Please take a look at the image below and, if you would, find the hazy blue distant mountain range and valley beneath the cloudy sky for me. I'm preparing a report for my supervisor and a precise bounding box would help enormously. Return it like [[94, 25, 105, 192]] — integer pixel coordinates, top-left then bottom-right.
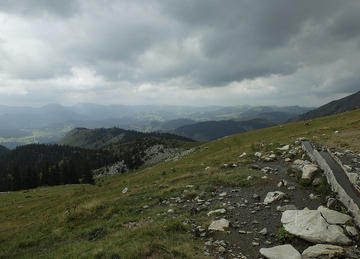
[[0, 104, 311, 148]]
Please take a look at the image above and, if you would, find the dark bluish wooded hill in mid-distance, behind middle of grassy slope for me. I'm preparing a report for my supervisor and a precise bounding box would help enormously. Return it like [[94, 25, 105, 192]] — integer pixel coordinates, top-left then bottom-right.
[[174, 119, 276, 141]]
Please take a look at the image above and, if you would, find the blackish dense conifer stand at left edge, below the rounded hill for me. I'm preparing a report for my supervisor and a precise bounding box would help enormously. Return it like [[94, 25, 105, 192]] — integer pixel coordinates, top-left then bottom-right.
[[0, 144, 116, 191]]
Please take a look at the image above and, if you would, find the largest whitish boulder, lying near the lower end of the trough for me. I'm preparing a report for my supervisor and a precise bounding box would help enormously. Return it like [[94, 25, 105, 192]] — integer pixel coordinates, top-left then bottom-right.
[[281, 210, 351, 245]]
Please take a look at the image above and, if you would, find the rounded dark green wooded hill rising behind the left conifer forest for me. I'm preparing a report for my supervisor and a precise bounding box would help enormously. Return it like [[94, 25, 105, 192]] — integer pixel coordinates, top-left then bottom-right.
[[58, 128, 192, 149]]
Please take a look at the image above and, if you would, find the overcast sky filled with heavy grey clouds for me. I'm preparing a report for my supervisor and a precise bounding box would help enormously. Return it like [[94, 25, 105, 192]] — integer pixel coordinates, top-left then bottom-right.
[[0, 0, 360, 106]]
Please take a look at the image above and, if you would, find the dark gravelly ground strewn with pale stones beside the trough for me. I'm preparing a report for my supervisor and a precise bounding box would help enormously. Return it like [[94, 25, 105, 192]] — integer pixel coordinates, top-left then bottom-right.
[[153, 142, 360, 258]]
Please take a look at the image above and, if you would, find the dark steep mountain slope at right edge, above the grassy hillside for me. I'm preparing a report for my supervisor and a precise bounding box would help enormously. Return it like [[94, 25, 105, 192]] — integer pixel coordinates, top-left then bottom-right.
[[291, 91, 360, 121]]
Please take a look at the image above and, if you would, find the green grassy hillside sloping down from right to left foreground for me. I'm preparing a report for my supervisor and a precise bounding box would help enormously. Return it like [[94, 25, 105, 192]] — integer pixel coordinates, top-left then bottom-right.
[[0, 110, 360, 258]]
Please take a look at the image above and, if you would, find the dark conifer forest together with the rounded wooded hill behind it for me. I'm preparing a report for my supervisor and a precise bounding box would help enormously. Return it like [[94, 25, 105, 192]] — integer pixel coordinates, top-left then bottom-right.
[[0, 128, 197, 191]]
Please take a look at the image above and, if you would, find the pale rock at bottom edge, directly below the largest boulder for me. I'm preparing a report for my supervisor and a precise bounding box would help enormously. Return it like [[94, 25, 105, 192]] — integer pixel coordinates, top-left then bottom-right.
[[302, 244, 345, 259]]
